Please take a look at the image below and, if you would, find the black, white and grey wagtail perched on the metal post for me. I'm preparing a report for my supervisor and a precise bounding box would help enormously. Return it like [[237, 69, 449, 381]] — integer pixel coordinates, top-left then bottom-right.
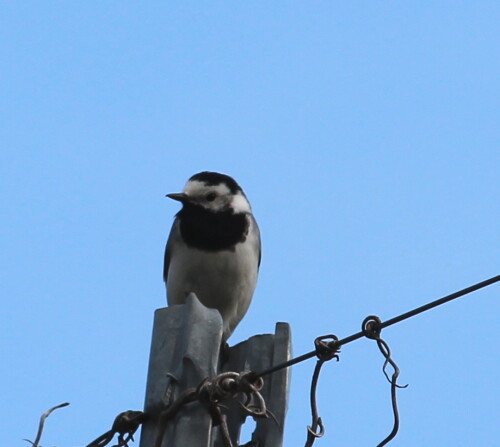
[[163, 172, 261, 341]]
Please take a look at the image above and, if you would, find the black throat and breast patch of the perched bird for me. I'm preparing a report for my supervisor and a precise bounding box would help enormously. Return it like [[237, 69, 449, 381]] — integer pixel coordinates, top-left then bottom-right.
[[177, 203, 249, 251]]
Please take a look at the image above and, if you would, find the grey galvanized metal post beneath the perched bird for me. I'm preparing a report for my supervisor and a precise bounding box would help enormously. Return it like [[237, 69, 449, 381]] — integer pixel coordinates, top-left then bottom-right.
[[140, 294, 291, 447]]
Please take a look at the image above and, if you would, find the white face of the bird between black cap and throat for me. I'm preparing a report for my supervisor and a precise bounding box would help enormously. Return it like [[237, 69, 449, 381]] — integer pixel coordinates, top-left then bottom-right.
[[183, 180, 251, 213]]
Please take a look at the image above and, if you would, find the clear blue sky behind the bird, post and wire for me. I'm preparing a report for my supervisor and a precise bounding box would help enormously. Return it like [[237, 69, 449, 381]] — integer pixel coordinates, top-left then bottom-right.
[[0, 0, 500, 447]]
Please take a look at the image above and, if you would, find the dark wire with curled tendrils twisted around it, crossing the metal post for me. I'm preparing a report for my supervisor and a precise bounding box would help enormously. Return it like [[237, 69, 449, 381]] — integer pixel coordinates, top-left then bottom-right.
[[80, 275, 500, 447]]
